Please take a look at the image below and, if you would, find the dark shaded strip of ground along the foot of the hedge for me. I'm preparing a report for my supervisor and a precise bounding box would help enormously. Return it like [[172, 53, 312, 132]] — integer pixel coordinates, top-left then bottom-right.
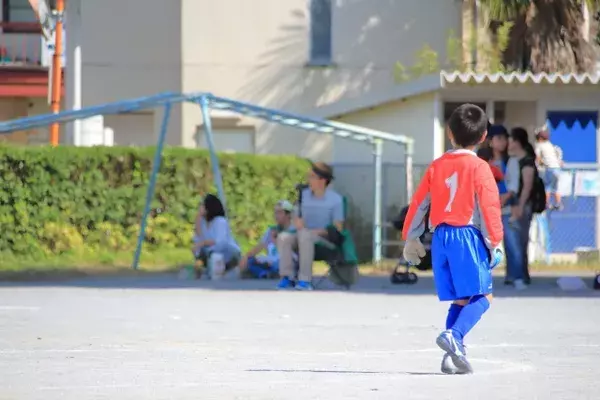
[[0, 272, 600, 298]]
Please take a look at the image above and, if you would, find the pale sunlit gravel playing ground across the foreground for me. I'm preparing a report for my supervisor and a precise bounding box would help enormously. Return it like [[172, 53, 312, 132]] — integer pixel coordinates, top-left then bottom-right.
[[0, 275, 600, 400]]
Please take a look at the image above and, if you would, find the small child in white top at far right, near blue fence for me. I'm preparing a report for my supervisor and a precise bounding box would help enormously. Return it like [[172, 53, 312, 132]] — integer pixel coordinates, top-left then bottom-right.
[[535, 126, 563, 210]]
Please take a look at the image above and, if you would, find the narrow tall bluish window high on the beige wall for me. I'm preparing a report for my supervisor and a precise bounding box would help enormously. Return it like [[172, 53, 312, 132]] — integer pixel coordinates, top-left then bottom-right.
[[309, 0, 332, 65]]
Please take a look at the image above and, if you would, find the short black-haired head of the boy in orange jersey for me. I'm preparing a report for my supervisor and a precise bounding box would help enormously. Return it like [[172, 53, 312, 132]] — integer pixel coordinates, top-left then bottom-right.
[[448, 103, 489, 147]]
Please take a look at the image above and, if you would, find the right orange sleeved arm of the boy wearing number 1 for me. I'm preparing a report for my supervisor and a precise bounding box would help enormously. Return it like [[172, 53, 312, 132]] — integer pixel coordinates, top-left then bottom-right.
[[475, 165, 504, 249]]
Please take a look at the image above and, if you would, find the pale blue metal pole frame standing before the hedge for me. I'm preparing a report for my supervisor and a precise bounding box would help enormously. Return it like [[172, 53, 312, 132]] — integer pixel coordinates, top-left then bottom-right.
[[0, 93, 414, 269]]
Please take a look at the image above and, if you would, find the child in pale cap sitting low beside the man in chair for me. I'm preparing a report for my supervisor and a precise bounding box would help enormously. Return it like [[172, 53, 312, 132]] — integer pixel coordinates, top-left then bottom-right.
[[240, 200, 294, 279]]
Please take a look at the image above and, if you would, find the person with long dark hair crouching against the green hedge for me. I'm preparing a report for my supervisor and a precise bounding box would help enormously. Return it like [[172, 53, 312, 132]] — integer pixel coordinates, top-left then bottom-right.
[[193, 194, 240, 276]]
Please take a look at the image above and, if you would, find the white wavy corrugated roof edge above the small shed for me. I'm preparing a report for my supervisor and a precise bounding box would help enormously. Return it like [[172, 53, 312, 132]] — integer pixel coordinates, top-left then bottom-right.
[[440, 71, 600, 85]]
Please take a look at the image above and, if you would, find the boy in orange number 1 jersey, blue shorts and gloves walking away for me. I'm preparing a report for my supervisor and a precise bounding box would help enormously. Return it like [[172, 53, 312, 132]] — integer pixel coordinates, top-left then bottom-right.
[[402, 104, 503, 374]]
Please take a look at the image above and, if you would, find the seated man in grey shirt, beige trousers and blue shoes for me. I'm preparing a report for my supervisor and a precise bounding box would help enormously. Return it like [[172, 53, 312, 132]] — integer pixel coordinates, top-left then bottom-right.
[[277, 162, 344, 290]]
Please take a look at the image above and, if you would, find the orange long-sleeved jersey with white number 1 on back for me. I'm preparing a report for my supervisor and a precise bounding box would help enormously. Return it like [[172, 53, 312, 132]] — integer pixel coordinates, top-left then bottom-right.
[[402, 150, 503, 248]]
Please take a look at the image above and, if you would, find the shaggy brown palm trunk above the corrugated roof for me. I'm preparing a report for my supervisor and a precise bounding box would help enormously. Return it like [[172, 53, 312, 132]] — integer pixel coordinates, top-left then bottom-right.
[[480, 0, 600, 73]]
